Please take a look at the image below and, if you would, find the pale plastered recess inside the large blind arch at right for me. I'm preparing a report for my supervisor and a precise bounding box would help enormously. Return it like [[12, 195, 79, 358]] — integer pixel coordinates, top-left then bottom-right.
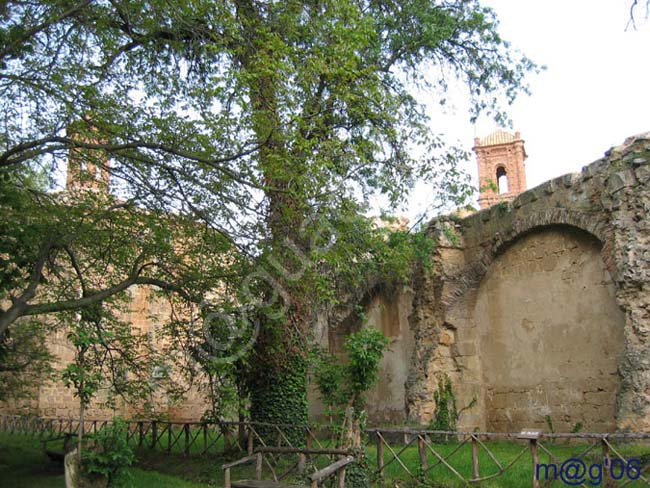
[[474, 226, 624, 432]]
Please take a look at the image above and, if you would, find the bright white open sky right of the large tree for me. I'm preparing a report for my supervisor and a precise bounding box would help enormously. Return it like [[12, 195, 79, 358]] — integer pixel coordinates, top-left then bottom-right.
[[400, 0, 650, 218]]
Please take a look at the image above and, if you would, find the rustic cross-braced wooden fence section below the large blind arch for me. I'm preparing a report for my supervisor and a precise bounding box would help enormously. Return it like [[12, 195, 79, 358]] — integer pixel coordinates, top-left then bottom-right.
[[367, 429, 650, 488]]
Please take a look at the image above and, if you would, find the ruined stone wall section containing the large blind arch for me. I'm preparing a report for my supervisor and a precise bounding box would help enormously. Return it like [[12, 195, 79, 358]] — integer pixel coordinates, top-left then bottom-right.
[[405, 134, 650, 432]]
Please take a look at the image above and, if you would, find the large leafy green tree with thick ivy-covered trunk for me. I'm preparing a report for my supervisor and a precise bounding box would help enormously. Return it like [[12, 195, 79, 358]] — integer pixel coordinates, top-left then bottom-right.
[[0, 0, 534, 421]]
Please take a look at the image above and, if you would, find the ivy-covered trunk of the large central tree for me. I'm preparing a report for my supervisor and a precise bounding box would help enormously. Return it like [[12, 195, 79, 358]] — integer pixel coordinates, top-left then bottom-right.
[[235, 0, 309, 445]]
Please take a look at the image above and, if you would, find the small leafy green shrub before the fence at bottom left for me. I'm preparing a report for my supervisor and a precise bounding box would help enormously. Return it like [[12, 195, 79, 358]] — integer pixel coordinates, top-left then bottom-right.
[[83, 417, 135, 486]]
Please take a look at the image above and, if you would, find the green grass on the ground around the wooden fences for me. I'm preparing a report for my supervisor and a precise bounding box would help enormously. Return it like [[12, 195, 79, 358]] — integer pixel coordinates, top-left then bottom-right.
[[0, 434, 650, 488]]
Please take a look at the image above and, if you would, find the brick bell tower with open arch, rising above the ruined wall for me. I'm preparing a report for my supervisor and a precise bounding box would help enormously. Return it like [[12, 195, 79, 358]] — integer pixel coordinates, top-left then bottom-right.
[[473, 130, 528, 209]]
